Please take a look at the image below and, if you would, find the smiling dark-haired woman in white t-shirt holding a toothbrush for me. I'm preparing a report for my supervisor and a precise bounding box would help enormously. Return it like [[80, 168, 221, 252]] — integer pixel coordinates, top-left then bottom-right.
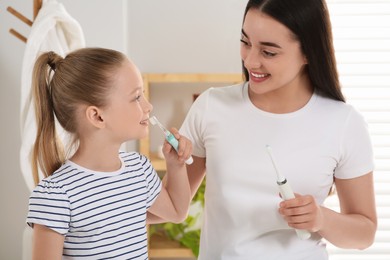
[[181, 0, 377, 260]]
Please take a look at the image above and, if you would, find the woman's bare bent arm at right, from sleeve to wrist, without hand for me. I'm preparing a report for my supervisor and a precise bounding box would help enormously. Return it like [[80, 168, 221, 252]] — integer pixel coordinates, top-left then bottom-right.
[[319, 172, 377, 249]]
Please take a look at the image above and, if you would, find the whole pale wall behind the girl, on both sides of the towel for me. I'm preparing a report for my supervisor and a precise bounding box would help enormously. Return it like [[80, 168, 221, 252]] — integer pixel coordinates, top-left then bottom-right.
[[0, 0, 246, 260]]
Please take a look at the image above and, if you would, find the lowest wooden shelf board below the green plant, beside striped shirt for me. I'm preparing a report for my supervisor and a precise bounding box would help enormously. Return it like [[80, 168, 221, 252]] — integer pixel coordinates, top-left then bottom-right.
[[149, 234, 195, 259]]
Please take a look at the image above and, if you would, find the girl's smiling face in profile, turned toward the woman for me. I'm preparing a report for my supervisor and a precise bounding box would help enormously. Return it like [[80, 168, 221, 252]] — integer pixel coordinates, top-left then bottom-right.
[[103, 61, 153, 143]]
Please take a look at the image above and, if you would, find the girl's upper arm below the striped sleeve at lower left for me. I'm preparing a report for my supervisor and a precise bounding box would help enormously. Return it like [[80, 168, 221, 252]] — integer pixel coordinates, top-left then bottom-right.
[[32, 224, 64, 260]]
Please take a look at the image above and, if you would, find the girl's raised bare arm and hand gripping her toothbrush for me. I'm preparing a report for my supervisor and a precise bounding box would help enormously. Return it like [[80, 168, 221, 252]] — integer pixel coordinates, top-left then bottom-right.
[[147, 129, 192, 224]]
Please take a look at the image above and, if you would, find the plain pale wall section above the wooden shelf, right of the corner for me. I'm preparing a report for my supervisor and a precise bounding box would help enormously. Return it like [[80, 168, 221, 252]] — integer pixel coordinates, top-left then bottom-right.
[[128, 0, 247, 73]]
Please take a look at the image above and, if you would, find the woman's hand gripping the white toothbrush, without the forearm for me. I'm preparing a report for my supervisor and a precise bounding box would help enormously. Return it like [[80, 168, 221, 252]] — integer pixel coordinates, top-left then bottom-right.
[[279, 194, 324, 232]]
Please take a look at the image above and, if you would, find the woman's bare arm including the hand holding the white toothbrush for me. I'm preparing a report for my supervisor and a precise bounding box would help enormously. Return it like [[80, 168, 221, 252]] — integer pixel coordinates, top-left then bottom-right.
[[279, 172, 377, 249]]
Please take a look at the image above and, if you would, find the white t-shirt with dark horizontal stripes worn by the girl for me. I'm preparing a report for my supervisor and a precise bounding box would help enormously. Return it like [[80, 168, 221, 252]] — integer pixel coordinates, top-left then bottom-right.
[[27, 152, 161, 259]]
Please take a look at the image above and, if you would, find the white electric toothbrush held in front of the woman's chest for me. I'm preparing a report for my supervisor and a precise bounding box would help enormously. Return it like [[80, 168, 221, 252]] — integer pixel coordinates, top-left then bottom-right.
[[266, 145, 311, 239]]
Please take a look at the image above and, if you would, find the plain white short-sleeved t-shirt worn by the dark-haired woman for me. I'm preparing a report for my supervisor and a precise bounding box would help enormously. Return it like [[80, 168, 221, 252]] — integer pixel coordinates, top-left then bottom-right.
[[180, 84, 374, 260]]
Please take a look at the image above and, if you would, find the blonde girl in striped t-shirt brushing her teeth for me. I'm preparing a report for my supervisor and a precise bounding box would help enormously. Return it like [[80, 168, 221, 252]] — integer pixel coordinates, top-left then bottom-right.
[[27, 48, 192, 259]]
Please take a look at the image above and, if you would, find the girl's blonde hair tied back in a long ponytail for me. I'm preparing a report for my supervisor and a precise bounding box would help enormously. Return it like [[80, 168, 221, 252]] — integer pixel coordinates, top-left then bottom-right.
[[32, 48, 126, 185]]
